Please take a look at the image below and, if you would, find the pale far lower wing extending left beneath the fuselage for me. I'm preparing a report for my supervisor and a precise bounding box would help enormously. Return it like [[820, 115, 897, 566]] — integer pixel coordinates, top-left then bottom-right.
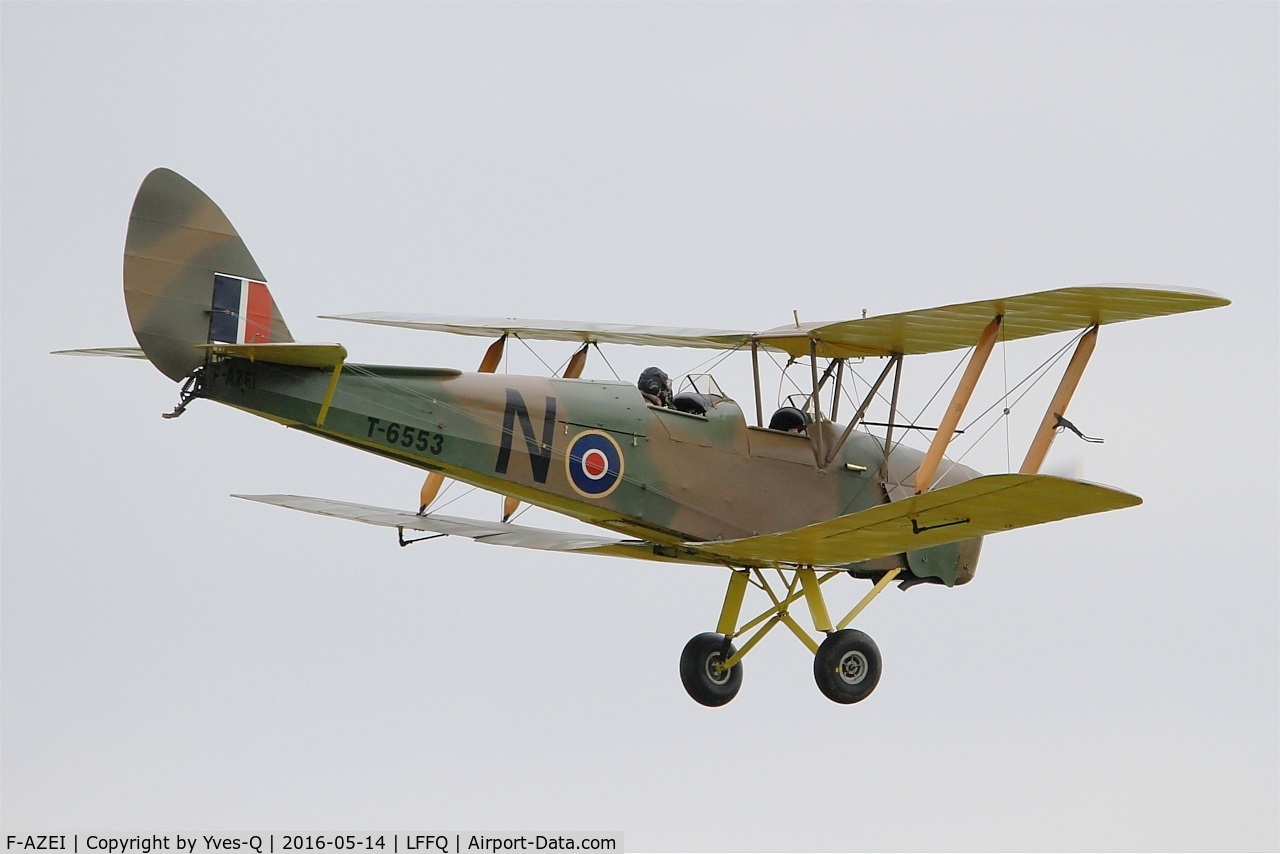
[[234, 495, 723, 565]]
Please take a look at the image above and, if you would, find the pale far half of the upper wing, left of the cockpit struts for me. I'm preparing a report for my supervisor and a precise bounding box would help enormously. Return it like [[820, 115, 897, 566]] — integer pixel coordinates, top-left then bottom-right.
[[320, 311, 753, 350]]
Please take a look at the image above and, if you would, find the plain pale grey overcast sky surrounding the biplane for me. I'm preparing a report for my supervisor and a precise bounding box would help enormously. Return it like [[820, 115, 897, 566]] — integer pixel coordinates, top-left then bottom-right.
[[0, 3, 1280, 850]]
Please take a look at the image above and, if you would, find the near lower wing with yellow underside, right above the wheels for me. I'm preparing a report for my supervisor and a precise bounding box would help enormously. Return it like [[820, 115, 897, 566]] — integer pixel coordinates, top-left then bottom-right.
[[686, 474, 1142, 566]]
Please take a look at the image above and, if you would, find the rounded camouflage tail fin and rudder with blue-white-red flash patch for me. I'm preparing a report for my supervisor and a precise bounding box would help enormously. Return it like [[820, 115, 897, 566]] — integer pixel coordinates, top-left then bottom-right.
[[124, 169, 293, 380]]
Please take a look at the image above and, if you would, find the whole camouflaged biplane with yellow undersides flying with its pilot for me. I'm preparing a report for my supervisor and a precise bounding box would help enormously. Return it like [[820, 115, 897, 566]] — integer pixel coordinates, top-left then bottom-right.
[[64, 169, 1229, 705]]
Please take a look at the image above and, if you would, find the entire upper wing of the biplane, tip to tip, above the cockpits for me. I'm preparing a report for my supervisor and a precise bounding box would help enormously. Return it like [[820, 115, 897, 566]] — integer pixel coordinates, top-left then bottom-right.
[[323, 284, 1230, 359]]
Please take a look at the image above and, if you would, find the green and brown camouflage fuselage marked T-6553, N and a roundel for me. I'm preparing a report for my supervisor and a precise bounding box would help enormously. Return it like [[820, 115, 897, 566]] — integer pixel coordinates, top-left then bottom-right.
[[204, 359, 977, 584]]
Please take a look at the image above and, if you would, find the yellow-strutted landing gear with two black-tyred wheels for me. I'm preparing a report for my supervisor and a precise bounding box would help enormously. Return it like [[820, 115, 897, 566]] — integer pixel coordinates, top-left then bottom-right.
[[680, 567, 902, 705]]
